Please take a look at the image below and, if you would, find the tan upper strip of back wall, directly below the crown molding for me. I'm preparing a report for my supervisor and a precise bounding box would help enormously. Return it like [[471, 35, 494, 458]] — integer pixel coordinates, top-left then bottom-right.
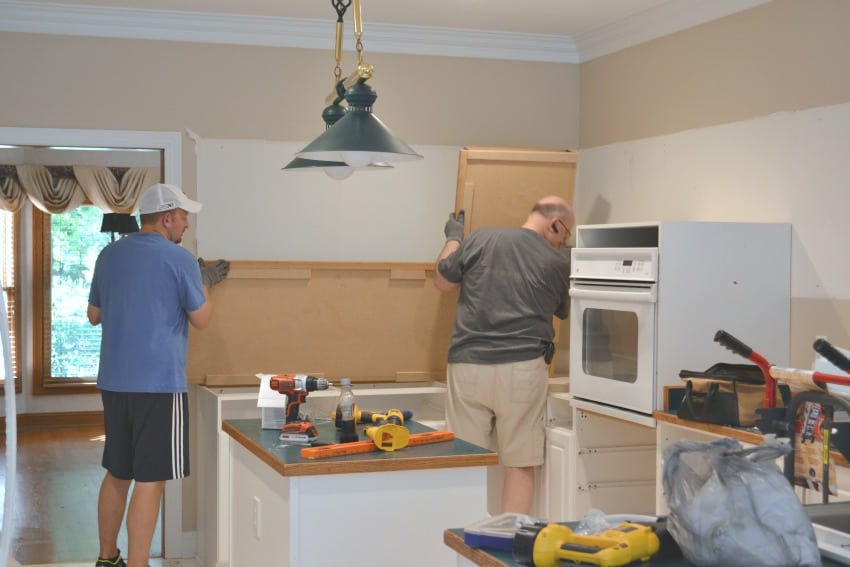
[[0, 33, 578, 170]]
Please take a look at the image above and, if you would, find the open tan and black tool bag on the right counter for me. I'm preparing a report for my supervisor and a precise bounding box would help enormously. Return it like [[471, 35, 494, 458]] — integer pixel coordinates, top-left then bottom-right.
[[677, 363, 781, 427]]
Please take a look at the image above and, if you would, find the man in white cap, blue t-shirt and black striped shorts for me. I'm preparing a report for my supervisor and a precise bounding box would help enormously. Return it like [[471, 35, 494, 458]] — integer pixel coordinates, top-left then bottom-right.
[[88, 183, 230, 567]]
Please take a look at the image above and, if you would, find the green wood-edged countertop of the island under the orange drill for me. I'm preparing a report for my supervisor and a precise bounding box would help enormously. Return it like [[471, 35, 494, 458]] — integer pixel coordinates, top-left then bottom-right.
[[221, 419, 499, 476]]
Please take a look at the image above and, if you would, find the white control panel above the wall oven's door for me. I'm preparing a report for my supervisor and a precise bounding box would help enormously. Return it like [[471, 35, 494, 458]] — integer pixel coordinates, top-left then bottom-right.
[[570, 248, 658, 282]]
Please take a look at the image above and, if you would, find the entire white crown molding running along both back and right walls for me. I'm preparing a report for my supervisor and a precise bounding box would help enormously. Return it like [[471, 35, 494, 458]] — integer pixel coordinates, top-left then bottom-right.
[[0, 0, 770, 63]]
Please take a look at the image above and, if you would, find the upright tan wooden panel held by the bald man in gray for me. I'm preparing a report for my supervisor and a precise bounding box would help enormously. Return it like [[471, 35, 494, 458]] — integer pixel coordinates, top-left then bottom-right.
[[455, 148, 578, 234]]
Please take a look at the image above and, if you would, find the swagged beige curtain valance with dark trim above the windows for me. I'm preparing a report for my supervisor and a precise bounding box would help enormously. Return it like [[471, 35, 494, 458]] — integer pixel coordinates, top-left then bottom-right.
[[0, 168, 160, 214]]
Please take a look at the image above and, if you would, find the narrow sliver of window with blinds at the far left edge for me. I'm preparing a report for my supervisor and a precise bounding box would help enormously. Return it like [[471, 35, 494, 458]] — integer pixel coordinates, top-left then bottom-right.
[[0, 211, 21, 393]]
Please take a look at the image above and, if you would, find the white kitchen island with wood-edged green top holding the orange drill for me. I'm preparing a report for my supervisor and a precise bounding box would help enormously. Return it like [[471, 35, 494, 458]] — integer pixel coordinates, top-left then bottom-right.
[[222, 419, 498, 567]]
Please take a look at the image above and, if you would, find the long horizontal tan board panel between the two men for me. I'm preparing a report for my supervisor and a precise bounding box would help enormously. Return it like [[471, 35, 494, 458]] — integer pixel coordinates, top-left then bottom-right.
[[188, 261, 457, 383]]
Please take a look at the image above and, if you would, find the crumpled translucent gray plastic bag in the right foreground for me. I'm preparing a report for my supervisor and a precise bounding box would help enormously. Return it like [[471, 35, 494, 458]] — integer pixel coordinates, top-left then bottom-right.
[[662, 437, 821, 567]]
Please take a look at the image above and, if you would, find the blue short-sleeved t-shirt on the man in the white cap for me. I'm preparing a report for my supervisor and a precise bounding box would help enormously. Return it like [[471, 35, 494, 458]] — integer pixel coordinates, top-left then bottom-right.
[[89, 232, 206, 393]]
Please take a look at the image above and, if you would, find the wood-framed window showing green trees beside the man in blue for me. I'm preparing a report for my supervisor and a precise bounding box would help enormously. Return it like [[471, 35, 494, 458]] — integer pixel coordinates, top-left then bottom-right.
[[33, 205, 110, 394]]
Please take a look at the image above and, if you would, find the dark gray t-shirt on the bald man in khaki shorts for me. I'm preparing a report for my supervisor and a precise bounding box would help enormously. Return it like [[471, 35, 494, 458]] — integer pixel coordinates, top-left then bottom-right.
[[438, 228, 570, 364]]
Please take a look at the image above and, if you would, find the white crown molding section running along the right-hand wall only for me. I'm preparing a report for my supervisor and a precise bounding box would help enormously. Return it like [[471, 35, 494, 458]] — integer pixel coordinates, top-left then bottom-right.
[[574, 0, 772, 62]]
